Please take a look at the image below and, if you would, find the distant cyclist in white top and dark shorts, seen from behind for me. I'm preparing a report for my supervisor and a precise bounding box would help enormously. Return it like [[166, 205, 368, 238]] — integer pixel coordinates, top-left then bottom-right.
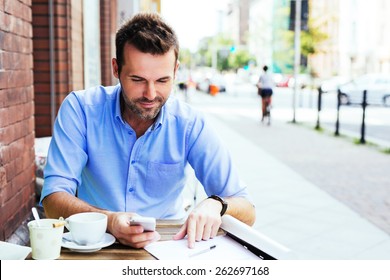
[[257, 65, 274, 124]]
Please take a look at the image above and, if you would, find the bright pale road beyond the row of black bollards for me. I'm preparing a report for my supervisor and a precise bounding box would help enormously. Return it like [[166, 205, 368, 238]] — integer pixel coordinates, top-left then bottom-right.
[[190, 84, 390, 149]]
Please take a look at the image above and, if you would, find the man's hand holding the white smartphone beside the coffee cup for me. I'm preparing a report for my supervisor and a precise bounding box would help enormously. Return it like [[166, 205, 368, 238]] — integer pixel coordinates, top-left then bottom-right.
[[108, 212, 161, 248]]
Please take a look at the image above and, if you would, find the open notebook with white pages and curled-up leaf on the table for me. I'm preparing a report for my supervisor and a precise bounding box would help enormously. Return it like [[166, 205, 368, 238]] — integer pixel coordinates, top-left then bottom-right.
[[145, 215, 289, 260]]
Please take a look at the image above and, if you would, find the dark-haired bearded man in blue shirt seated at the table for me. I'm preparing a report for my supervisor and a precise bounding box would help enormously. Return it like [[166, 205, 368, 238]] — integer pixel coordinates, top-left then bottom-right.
[[41, 14, 255, 248]]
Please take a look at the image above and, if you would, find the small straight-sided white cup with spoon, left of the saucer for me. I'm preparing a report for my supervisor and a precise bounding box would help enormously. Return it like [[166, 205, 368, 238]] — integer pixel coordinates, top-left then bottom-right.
[[27, 219, 64, 260]]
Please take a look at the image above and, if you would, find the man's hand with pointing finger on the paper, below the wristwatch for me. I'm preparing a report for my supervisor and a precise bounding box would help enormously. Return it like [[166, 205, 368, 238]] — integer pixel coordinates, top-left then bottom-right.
[[173, 199, 222, 248]]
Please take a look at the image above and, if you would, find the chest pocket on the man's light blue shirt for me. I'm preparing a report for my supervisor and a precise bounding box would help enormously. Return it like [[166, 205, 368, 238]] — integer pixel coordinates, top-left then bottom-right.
[[145, 162, 185, 199]]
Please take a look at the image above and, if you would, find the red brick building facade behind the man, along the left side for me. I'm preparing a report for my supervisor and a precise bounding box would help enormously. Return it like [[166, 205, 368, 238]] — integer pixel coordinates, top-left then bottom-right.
[[0, 0, 160, 240]]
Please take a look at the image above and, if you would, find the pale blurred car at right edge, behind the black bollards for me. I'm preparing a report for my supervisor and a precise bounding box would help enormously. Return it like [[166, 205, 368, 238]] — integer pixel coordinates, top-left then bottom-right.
[[340, 74, 390, 106]]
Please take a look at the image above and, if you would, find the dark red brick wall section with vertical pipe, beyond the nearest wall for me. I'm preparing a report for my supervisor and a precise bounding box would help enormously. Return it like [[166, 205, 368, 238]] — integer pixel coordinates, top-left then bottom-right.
[[32, 0, 77, 137]]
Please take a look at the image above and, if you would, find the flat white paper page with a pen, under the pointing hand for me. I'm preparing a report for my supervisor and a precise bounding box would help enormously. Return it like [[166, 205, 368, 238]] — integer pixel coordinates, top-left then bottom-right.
[[145, 235, 261, 260]]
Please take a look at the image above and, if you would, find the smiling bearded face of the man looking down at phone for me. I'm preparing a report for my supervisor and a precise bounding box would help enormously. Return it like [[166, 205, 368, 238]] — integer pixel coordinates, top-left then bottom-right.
[[112, 44, 178, 120]]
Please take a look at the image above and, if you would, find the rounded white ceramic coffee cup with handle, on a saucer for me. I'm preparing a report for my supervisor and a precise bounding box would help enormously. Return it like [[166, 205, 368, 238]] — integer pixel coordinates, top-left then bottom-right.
[[65, 212, 107, 245]]
